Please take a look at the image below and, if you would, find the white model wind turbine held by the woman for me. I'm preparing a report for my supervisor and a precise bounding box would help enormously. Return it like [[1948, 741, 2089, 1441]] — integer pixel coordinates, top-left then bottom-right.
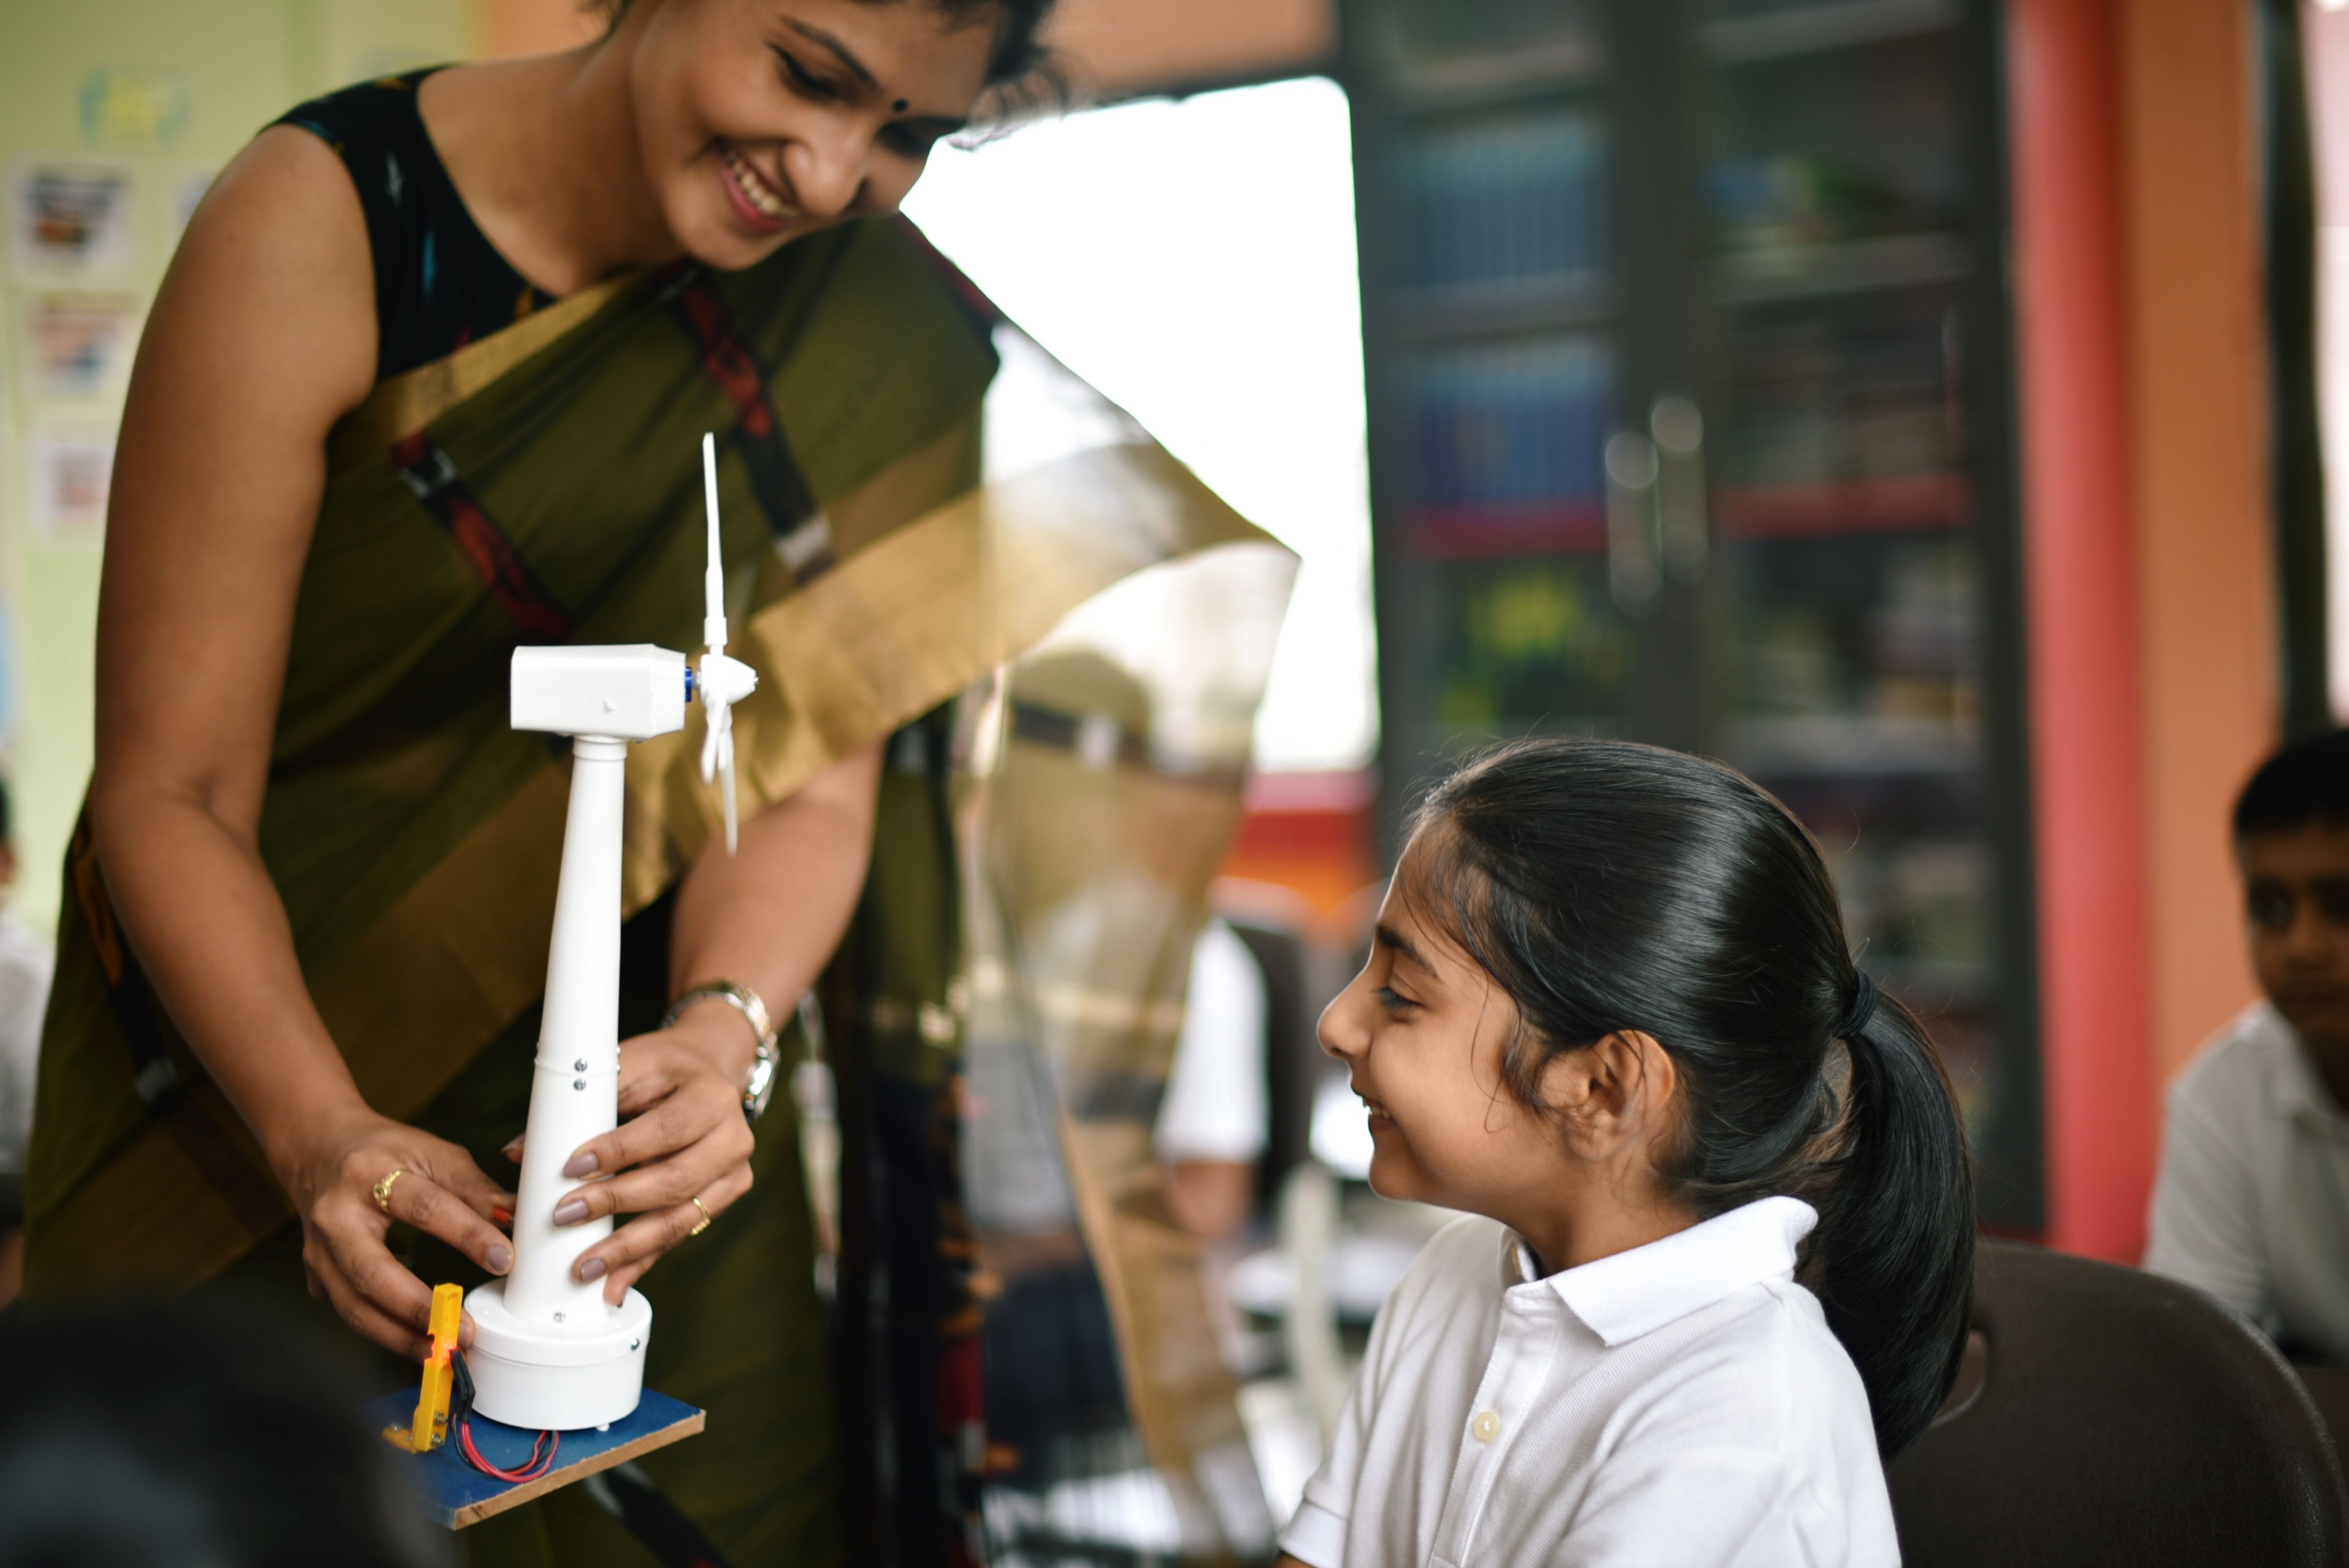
[[465, 435, 759, 1432]]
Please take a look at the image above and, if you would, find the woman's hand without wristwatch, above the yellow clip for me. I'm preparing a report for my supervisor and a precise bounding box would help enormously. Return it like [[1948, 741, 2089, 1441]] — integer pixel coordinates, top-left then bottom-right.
[[277, 1112, 514, 1361]]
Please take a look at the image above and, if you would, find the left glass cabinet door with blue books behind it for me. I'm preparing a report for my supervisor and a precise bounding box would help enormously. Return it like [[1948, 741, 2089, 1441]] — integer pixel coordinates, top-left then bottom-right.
[[1351, 0, 1637, 783]]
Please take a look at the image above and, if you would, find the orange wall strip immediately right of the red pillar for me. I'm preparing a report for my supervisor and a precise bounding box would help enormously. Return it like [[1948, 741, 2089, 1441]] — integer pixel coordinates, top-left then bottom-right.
[[2119, 0, 2283, 1100]]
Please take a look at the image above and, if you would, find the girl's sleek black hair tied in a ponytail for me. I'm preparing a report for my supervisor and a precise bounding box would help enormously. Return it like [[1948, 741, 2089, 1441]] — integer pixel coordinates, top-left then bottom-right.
[[1400, 740, 1973, 1457]]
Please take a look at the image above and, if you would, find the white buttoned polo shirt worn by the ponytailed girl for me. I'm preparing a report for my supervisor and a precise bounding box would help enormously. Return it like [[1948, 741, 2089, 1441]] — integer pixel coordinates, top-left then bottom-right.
[[1280, 1196, 1901, 1568]]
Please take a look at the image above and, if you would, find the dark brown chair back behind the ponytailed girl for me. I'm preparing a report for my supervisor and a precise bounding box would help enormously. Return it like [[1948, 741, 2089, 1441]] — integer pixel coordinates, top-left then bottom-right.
[[1888, 1241, 2349, 1568]]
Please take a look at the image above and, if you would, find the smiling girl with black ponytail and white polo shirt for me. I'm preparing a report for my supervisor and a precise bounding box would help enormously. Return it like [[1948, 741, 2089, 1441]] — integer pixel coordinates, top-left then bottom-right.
[[1280, 740, 1973, 1568]]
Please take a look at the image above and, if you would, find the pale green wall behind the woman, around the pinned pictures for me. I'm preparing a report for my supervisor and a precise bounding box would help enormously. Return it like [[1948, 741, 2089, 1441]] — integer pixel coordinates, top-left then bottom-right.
[[0, 0, 477, 931]]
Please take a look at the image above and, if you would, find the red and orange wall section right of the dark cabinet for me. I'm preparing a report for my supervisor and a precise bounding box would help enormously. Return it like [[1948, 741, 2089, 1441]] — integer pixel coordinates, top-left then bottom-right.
[[2006, 0, 2278, 1262]]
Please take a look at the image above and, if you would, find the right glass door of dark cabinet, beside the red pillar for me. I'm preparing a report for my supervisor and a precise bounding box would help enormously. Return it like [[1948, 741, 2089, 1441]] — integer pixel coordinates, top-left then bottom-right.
[[1687, 0, 2036, 1222]]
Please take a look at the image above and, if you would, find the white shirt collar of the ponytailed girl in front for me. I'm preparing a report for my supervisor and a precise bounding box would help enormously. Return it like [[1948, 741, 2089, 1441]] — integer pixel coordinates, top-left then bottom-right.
[[1501, 1196, 1818, 1347]]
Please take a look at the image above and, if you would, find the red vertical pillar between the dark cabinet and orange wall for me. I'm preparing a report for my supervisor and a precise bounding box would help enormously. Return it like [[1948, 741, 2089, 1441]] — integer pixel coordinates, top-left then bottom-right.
[[2006, 0, 2154, 1262]]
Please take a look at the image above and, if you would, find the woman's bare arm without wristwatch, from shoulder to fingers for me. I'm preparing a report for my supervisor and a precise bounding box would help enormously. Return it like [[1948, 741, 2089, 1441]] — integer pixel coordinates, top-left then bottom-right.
[[89, 127, 505, 1349]]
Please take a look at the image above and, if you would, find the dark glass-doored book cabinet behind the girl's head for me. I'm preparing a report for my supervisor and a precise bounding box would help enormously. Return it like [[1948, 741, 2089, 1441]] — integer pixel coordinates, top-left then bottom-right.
[[1341, 0, 2044, 1232]]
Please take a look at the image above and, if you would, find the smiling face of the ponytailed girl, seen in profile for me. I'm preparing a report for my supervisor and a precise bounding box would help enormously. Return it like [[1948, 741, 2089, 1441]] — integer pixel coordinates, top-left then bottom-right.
[[1320, 834, 1579, 1230]]
